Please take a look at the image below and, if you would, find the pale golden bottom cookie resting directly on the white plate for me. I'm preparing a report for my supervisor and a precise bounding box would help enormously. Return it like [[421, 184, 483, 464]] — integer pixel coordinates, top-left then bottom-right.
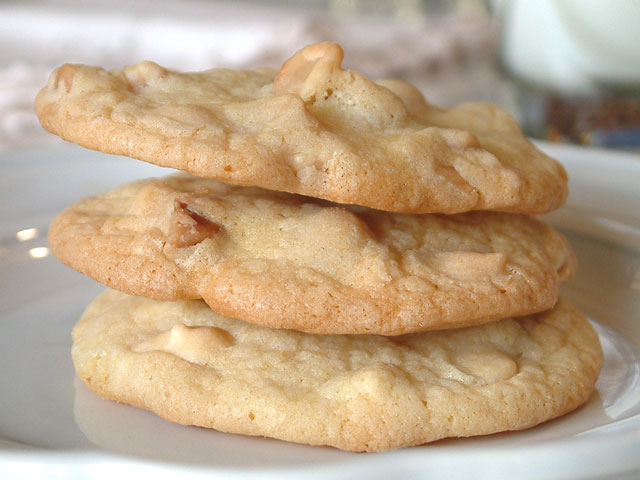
[[72, 290, 602, 451]]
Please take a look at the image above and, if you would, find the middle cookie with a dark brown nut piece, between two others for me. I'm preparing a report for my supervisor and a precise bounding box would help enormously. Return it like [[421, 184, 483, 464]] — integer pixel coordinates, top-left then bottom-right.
[[49, 174, 576, 335]]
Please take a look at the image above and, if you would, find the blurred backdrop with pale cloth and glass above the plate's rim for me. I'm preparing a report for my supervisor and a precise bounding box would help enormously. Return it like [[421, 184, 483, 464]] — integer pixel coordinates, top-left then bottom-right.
[[0, 0, 640, 150]]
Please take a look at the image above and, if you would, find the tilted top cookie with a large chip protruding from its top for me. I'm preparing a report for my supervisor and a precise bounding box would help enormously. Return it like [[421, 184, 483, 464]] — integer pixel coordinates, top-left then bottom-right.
[[36, 43, 567, 213]]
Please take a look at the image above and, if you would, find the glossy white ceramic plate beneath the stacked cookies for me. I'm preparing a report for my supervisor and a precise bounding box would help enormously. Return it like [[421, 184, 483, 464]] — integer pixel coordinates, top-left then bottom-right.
[[0, 144, 640, 480]]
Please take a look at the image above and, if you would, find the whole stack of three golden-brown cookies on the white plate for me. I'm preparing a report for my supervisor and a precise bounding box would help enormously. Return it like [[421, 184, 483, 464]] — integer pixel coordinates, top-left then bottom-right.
[[36, 43, 602, 451]]
